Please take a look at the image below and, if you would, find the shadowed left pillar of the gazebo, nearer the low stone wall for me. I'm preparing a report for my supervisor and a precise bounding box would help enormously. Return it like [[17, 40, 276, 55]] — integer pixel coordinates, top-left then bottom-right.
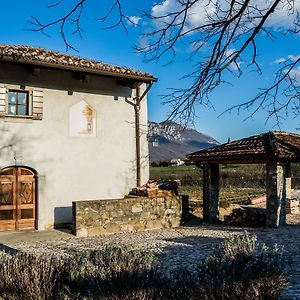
[[203, 163, 220, 223]]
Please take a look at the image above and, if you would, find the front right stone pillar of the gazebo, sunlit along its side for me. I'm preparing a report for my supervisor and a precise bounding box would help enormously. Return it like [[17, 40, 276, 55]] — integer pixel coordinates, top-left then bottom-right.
[[266, 162, 291, 227]]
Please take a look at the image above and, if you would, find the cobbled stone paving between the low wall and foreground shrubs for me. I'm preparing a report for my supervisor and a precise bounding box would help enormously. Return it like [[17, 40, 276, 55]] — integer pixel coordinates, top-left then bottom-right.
[[0, 215, 300, 300]]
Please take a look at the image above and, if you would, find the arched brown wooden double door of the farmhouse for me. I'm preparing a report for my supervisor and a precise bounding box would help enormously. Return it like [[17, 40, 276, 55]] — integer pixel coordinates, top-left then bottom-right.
[[0, 167, 36, 231]]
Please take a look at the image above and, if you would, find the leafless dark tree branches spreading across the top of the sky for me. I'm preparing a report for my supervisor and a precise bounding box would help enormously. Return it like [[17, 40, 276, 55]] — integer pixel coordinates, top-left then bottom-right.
[[30, 0, 300, 126]]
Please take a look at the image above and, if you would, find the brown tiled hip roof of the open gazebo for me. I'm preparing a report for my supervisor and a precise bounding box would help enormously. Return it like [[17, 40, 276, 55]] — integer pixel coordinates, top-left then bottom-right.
[[187, 131, 300, 163]]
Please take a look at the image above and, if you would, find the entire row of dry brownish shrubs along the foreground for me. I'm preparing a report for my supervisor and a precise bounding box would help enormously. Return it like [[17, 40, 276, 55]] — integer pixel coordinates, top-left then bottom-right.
[[0, 233, 286, 300]]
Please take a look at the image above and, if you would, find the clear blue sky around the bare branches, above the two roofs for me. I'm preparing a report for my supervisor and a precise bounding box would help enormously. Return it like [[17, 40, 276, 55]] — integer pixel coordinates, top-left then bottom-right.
[[0, 0, 300, 142]]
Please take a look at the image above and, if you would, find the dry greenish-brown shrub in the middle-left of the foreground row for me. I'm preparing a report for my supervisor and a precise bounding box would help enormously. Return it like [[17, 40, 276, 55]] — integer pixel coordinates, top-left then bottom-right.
[[60, 246, 159, 299]]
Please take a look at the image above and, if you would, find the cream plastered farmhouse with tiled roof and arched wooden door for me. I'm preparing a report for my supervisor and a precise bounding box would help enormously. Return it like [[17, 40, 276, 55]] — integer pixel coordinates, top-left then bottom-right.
[[0, 45, 156, 230]]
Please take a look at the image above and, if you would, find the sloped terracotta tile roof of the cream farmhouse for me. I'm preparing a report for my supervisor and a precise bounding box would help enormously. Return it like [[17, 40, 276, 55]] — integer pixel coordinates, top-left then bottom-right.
[[0, 44, 157, 82]]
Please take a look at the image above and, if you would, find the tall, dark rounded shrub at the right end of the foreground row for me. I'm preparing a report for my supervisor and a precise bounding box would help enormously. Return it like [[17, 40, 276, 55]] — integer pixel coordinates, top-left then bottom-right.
[[199, 233, 286, 300]]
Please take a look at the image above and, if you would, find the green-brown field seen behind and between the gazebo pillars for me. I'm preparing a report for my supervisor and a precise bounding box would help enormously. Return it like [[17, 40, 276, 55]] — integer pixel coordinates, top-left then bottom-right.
[[150, 164, 300, 207]]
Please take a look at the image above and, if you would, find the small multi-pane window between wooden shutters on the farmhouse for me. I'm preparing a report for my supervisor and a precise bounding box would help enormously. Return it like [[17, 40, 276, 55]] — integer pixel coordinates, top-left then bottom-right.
[[8, 90, 29, 116]]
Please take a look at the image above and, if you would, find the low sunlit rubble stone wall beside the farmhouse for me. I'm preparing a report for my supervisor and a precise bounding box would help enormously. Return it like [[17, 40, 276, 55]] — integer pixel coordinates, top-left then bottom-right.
[[73, 197, 182, 237]]
